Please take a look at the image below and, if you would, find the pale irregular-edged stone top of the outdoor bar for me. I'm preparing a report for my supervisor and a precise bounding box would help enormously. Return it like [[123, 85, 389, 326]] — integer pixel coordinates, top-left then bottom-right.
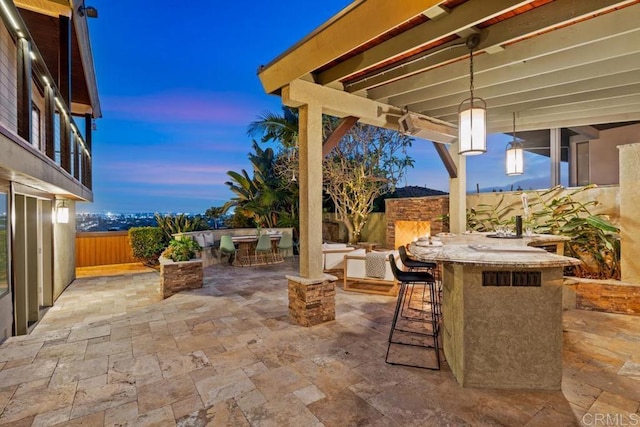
[[409, 233, 580, 268]]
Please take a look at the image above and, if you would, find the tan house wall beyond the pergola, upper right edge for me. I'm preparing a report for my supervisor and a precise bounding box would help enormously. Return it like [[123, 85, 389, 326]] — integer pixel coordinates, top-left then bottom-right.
[[589, 124, 640, 185]]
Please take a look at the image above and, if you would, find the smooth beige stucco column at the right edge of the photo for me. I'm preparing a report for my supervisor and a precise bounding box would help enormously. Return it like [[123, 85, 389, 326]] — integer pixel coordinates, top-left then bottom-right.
[[618, 144, 640, 283]]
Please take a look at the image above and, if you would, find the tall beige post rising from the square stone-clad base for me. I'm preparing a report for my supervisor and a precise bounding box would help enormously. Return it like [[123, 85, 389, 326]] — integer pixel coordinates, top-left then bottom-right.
[[298, 104, 324, 279]]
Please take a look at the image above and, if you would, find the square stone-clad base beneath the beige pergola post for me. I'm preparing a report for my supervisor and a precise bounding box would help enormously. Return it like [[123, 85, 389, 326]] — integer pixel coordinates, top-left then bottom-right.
[[286, 274, 338, 326]]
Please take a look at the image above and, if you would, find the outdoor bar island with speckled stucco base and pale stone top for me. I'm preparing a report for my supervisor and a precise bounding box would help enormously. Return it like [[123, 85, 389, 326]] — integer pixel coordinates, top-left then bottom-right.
[[409, 233, 580, 390]]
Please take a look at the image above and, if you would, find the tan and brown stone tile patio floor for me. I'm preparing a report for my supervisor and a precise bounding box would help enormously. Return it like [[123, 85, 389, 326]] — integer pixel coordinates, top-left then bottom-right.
[[0, 263, 640, 426]]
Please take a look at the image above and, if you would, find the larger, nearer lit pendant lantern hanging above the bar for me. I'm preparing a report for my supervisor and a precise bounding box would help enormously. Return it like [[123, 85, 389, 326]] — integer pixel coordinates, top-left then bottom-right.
[[458, 34, 487, 156]]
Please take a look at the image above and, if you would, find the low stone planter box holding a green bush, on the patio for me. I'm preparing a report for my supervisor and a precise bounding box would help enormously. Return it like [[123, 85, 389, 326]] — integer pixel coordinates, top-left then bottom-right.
[[159, 257, 203, 298]]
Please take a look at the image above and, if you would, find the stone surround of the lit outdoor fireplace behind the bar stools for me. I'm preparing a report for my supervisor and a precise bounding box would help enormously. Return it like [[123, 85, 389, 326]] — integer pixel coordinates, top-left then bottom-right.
[[385, 196, 449, 249]]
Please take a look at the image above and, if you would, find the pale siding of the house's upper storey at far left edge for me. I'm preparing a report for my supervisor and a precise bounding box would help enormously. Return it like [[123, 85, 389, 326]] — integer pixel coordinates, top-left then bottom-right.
[[0, 25, 18, 133]]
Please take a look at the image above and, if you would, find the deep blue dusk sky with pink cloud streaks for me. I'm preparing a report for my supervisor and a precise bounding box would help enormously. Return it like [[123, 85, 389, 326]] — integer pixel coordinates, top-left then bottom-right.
[[78, 0, 560, 213]]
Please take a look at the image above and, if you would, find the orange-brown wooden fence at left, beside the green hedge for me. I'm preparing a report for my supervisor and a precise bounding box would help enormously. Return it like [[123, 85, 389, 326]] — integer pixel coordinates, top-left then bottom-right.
[[76, 231, 138, 267]]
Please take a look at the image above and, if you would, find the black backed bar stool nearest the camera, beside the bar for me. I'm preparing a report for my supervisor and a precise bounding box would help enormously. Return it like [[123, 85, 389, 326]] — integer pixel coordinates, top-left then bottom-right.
[[385, 254, 440, 370]]
